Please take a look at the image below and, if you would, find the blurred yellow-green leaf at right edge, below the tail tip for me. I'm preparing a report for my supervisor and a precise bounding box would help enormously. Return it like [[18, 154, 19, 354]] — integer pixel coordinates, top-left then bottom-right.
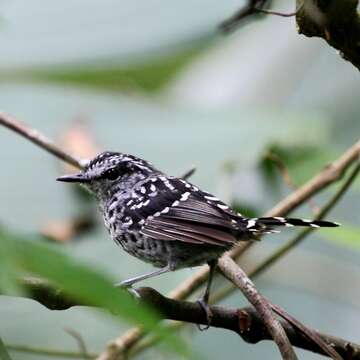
[[319, 224, 360, 251]]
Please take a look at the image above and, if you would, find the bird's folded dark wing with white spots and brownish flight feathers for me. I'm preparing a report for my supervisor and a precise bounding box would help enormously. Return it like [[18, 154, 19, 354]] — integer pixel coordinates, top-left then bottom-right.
[[124, 176, 242, 247]]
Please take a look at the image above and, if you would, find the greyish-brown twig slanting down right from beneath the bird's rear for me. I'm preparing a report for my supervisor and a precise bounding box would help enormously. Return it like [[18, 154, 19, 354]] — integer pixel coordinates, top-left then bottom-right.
[[218, 256, 297, 360]]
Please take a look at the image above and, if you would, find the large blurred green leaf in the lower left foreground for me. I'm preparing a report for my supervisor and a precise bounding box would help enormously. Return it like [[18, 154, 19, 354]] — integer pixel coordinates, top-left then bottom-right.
[[0, 231, 186, 354]]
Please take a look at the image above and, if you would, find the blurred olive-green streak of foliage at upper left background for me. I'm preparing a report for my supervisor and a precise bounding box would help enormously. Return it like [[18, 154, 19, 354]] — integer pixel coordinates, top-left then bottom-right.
[[0, 40, 210, 92]]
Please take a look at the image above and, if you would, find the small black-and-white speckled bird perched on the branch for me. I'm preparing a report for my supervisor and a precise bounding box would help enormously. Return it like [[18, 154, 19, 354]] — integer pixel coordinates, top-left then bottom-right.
[[57, 151, 339, 324]]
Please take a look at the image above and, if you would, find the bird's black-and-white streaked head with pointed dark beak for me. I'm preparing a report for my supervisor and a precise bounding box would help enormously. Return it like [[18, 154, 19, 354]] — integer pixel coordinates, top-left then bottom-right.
[[57, 151, 156, 199]]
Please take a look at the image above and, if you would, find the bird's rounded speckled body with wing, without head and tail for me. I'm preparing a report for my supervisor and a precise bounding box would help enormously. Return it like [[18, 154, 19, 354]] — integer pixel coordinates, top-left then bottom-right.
[[103, 173, 239, 268]]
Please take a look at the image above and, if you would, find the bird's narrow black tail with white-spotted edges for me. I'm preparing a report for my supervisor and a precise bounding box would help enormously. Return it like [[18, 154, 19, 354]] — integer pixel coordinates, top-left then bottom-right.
[[242, 217, 340, 235]]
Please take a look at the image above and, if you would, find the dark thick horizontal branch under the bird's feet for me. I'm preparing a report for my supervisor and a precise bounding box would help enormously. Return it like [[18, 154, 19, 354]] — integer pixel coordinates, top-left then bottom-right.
[[4, 279, 360, 360]]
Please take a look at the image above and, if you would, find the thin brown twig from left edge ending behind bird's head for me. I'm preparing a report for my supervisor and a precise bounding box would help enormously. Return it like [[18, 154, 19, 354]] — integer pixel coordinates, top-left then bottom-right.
[[0, 112, 86, 168]]
